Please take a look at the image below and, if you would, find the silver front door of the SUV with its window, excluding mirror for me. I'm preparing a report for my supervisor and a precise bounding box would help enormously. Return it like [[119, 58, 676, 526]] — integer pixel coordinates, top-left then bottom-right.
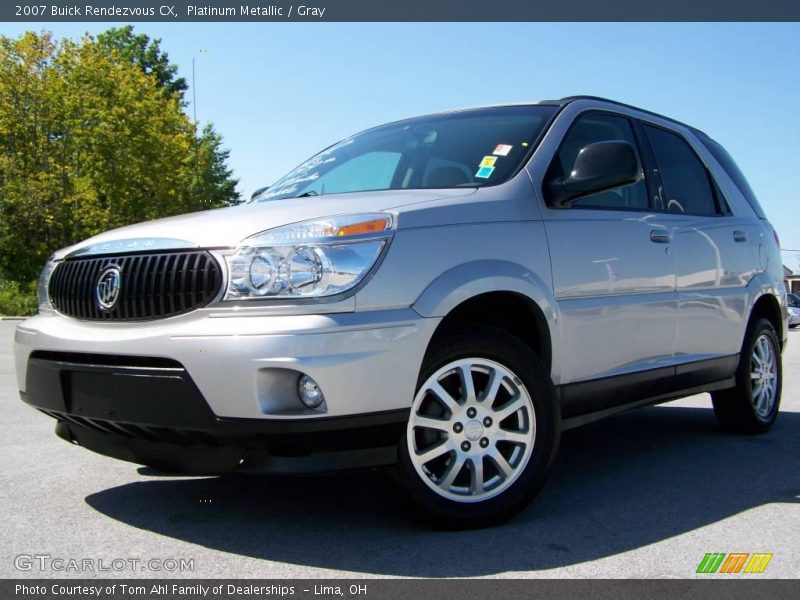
[[543, 113, 677, 417]]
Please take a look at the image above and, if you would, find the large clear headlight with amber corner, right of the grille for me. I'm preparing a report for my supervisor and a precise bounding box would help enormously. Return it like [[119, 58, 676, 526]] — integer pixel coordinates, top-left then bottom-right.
[[224, 213, 395, 300]]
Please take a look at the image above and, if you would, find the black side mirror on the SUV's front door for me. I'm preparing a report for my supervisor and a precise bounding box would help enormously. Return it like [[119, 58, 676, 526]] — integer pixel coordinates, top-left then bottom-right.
[[547, 140, 642, 208]]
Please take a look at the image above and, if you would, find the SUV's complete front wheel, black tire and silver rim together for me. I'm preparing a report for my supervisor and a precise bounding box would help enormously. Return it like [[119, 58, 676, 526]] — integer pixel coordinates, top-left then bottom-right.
[[398, 325, 559, 529]]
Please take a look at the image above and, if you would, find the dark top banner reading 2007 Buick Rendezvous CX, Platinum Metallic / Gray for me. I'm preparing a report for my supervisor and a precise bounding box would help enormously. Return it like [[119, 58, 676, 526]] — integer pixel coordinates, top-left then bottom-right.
[[0, 0, 800, 22]]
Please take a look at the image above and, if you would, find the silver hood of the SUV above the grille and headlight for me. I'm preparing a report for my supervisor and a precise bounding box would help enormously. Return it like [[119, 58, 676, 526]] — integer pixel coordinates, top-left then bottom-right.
[[55, 188, 476, 258]]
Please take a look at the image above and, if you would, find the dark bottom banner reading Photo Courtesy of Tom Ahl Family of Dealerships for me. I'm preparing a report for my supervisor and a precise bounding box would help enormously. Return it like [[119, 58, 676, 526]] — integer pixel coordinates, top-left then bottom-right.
[[0, 578, 800, 600]]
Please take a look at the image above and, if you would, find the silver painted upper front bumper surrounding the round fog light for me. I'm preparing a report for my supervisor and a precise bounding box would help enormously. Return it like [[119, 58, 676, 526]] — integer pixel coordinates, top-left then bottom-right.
[[14, 309, 440, 420]]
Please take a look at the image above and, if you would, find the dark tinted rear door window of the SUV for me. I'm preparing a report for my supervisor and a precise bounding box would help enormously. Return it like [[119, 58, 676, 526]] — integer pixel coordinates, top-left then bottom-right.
[[644, 125, 718, 215]]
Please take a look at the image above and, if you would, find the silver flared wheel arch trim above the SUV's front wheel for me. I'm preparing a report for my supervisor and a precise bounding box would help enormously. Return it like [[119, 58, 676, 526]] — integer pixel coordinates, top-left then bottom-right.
[[412, 260, 561, 382]]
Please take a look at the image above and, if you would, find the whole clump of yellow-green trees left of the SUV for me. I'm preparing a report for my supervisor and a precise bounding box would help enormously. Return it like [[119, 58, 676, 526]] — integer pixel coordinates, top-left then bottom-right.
[[0, 28, 238, 290]]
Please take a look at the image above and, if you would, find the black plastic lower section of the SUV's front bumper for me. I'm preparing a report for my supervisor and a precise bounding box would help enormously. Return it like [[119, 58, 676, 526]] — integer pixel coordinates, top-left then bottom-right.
[[21, 351, 408, 473]]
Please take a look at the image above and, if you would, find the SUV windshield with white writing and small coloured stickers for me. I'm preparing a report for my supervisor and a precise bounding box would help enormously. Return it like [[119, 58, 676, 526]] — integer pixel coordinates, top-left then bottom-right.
[[254, 106, 556, 202]]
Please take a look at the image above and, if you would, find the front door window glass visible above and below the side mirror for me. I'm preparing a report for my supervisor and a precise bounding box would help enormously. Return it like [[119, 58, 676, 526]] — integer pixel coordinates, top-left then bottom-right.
[[547, 114, 649, 210]]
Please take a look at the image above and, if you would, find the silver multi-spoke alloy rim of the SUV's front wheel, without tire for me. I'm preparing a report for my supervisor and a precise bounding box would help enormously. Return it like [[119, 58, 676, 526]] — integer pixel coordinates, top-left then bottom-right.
[[407, 358, 536, 503]]
